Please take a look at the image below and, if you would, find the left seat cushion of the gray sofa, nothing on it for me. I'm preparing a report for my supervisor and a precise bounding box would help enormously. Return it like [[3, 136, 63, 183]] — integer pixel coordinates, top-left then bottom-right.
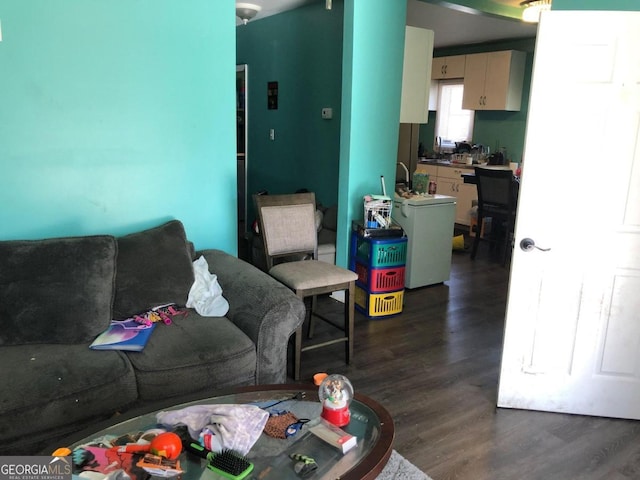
[[0, 345, 137, 454]]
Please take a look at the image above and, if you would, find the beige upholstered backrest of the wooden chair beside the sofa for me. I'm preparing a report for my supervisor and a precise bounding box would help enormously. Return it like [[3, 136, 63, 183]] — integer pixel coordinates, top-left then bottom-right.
[[253, 192, 318, 270]]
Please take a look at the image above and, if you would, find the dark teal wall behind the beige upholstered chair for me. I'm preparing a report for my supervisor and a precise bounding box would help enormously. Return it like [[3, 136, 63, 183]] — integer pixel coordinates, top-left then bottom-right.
[[236, 1, 343, 219]]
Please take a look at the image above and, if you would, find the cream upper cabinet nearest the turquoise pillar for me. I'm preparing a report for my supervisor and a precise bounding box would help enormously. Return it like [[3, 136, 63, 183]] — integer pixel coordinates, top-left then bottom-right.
[[400, 26, 433, 123]]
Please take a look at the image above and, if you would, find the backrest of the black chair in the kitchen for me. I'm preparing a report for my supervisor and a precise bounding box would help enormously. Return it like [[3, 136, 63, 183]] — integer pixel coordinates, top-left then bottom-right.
[[475, 167, 517, 213]]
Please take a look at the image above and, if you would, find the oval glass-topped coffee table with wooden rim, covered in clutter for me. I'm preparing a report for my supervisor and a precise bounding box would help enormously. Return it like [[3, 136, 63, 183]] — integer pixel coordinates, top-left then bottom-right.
[[67, 385, 394, 480]]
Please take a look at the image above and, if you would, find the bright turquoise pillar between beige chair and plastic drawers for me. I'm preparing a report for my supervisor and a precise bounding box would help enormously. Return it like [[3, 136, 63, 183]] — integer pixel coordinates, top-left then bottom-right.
[[336, 0, 407, 266]]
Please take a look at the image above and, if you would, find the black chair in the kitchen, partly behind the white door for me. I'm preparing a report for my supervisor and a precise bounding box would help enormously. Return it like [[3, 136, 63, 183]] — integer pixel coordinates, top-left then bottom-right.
[[471, 167, 519, 265]]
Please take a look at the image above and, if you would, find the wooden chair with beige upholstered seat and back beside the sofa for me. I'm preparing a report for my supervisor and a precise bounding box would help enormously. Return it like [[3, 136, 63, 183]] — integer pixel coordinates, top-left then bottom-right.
[[253, 193, 358, 380]]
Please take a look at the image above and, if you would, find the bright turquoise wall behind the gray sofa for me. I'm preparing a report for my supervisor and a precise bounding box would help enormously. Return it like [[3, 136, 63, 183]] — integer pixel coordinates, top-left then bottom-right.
[[0, 0, 237, 253]]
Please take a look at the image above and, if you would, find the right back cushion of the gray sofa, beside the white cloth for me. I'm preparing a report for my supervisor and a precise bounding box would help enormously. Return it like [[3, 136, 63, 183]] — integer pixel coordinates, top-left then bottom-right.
[[113, 220, 194, 319]]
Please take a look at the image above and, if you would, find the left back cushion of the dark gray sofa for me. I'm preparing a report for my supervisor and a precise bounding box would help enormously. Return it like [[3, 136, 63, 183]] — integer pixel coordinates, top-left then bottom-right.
[[0, 235, 117, 345]]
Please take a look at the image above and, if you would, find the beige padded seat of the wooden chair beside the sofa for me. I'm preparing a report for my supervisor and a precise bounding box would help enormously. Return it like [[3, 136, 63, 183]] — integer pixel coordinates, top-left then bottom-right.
[[269, 260, 358, 291]]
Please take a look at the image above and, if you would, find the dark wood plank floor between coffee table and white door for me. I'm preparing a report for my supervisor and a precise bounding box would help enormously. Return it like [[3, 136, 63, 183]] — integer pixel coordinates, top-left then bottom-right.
[[292, 247, 640, 480]]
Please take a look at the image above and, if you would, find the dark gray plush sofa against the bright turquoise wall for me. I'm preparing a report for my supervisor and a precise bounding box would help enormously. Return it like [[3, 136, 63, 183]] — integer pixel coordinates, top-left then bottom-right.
[[0, 220, 305, 455]]
